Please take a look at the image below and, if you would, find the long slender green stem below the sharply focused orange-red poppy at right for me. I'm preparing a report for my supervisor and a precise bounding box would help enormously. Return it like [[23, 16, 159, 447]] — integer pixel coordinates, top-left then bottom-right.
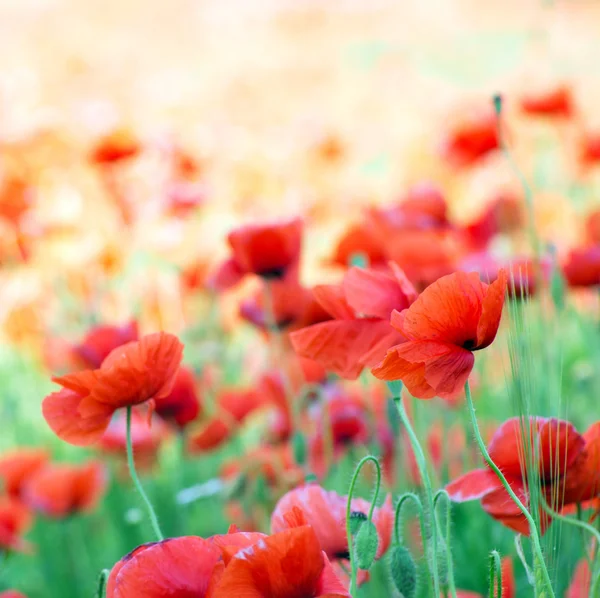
[[465, 380, 555, 598]]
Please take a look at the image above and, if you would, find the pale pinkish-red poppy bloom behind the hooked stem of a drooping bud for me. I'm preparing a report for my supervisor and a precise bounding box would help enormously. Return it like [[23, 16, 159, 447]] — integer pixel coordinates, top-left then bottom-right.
[[271, 484, 394, 561]]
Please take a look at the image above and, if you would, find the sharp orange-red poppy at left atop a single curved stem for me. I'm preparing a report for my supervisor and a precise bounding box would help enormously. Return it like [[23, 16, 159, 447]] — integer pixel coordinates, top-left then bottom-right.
[[42, 332, 183, 446]]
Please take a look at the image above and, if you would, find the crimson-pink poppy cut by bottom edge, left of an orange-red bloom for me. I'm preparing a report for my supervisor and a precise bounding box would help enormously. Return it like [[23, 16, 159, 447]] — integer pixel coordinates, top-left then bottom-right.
[[106, 536, 221, 598]]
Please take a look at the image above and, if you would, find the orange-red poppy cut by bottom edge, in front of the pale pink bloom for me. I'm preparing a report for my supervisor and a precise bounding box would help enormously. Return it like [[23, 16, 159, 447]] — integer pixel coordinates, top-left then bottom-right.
[[211, 525, 350, 598]]
